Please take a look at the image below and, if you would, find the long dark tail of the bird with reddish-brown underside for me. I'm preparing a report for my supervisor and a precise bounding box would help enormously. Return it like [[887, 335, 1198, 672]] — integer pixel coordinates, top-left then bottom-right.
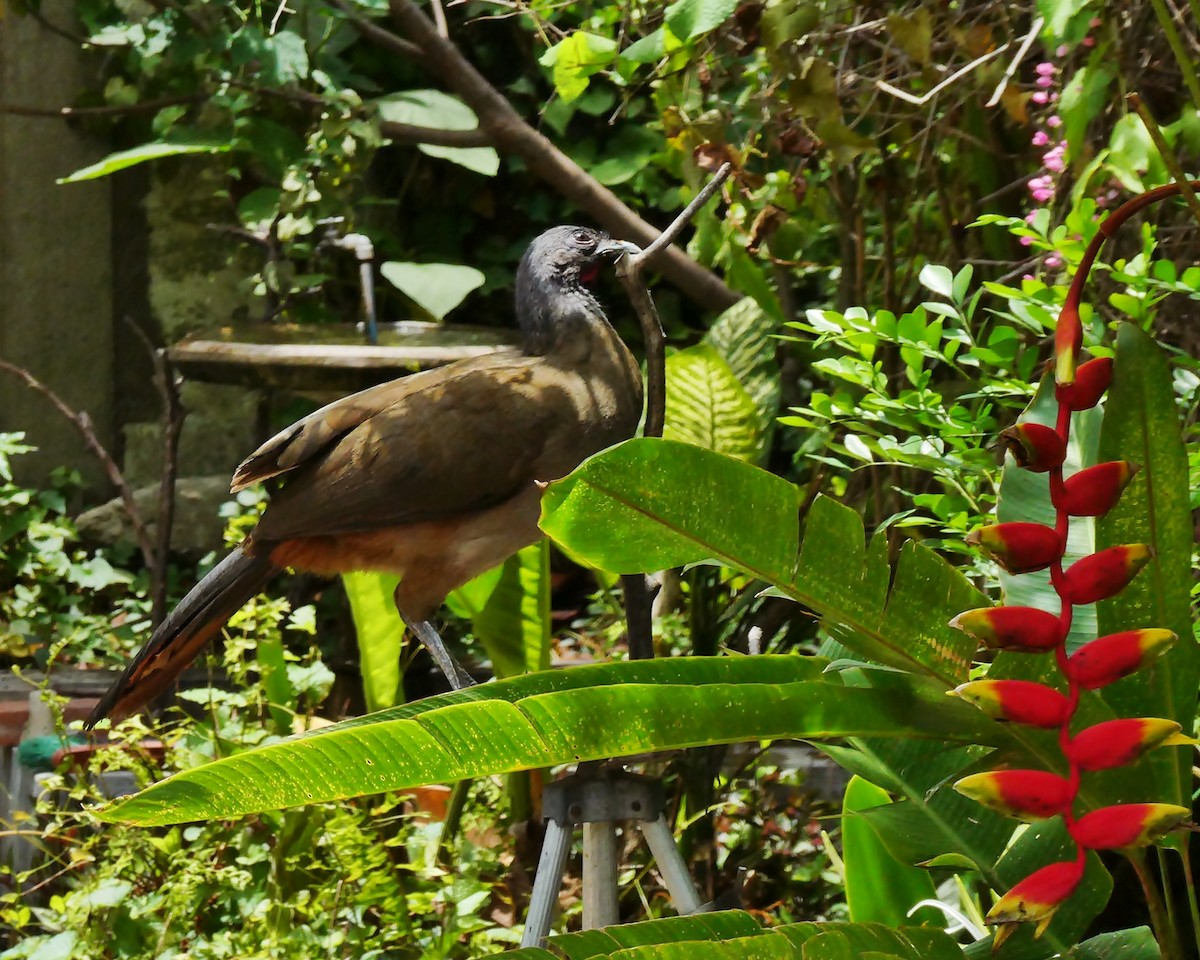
[[84, 547, 280, 728]]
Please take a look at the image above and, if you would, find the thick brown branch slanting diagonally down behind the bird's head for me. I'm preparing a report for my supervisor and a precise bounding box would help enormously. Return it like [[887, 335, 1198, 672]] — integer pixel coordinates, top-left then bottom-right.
[[369, 0, 738, 310]]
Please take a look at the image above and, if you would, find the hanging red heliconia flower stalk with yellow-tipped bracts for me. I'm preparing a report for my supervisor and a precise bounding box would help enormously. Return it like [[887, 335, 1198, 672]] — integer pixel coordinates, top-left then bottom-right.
[[952, 184, 1195, 949]]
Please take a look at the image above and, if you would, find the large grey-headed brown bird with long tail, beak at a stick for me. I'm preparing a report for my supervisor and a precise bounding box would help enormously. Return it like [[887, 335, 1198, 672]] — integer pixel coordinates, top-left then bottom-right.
[[85, 226, 643, 728]]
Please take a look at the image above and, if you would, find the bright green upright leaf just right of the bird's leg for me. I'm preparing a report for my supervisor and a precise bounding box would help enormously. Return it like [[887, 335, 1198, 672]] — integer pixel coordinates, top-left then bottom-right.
[[446, 540, 551, 677]]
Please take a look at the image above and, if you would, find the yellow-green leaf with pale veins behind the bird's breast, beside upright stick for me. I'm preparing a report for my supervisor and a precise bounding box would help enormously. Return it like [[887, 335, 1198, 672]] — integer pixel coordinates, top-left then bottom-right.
[[662, 343, 762, 462]]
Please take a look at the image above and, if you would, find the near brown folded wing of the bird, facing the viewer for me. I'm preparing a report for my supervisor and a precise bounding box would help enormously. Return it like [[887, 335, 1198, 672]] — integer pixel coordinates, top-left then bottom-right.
[[254, 355, 576, 542]]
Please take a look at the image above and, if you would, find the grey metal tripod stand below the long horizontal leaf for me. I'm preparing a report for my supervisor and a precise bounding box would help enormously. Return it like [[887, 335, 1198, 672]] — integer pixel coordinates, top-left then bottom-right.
[[521, 763, 704, 947]]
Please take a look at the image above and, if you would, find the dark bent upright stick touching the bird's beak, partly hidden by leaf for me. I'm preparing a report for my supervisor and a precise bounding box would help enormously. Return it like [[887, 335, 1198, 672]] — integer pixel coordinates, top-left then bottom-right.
[[617, 163, 733, 660]]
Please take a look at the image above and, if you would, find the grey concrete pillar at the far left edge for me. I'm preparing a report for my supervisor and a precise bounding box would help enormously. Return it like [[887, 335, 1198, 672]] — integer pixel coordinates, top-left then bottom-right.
[[0, 0, 114, 487]]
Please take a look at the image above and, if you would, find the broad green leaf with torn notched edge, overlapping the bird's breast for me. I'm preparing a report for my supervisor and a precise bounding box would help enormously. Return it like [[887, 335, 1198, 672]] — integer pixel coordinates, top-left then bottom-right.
[[541, 438, 986, 686]]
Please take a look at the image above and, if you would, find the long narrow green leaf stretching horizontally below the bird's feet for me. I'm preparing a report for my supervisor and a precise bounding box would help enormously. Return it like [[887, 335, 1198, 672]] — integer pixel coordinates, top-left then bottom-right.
[[100, 656, 998, 824]]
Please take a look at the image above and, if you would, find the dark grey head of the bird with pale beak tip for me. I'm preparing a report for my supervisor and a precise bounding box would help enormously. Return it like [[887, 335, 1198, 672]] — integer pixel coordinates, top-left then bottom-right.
[[516, 227, 638, 350]]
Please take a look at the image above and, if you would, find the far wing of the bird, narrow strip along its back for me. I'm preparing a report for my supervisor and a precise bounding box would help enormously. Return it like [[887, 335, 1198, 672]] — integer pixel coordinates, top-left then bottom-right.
[[230, 350, 517, 493]]
